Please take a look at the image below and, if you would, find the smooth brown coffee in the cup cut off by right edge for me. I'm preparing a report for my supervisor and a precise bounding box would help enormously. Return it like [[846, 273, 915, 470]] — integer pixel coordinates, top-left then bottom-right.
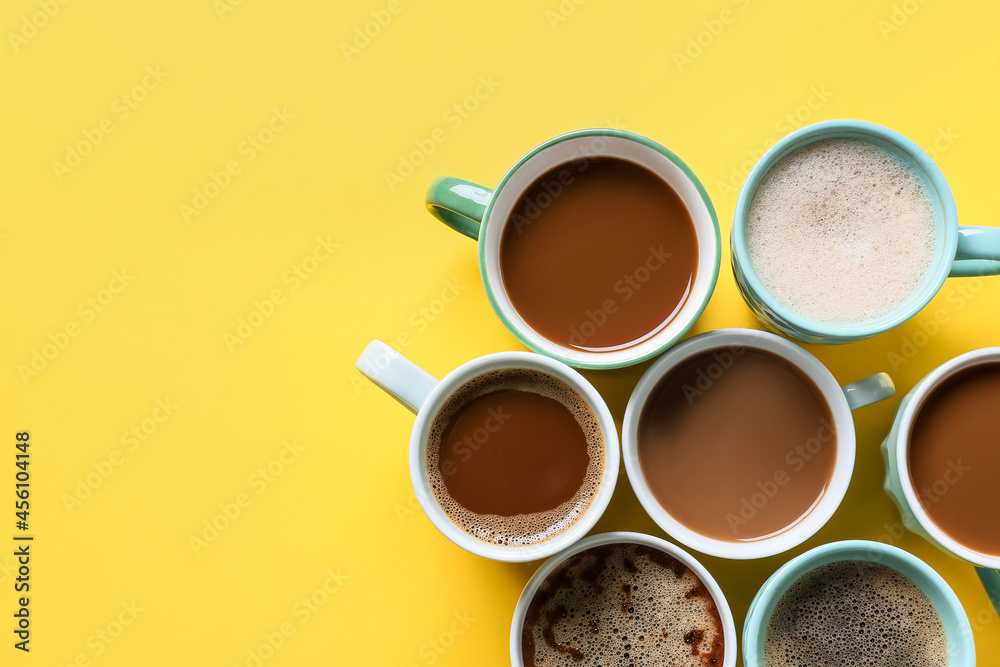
[[907, 362, 1000, 556]]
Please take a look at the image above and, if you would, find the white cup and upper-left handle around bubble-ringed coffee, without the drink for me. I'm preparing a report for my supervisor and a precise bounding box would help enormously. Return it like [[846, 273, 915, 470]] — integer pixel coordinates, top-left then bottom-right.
[[357, 340, 620, 562]]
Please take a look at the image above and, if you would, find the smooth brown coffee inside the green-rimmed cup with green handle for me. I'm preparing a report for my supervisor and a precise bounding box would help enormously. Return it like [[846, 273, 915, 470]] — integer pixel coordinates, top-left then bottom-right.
[[500, 158, 698, 351]]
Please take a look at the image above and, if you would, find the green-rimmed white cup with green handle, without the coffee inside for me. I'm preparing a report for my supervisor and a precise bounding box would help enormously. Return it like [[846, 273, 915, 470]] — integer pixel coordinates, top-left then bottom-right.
[[427, 129, 721, 368]]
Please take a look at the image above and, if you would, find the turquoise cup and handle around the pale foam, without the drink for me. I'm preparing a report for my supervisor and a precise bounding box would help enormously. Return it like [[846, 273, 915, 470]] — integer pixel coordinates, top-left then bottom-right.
[[732, 120, 1000, 344]]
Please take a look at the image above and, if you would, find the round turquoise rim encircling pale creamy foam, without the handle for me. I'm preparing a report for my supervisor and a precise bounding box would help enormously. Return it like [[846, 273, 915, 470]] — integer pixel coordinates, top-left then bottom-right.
[[732, 119, 958, 342]]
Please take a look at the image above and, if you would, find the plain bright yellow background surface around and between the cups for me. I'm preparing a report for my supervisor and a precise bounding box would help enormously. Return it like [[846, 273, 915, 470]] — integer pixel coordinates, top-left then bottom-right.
[[0, 0, 1000, 667]]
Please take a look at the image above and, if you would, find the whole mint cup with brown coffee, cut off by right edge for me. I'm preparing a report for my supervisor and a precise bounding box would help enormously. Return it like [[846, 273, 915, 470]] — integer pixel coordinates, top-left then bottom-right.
[[882, 347, 1000, 580]]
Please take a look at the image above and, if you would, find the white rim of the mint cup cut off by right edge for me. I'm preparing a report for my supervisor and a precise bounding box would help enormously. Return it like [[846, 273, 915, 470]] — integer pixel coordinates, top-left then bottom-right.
[[895, 347, 1000, 570]]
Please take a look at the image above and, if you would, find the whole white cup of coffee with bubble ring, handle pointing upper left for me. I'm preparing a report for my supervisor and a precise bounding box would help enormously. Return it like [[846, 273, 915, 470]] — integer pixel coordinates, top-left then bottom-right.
[[357, 340, 619, 562]]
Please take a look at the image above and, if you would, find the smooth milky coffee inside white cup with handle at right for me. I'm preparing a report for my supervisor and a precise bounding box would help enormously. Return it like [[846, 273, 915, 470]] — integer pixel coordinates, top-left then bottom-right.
[[638, 346, 837, 542]]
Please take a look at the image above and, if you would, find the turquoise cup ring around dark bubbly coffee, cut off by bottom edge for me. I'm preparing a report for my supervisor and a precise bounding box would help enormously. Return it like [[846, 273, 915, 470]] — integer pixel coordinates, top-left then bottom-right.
[[742, 540, 976, 667]]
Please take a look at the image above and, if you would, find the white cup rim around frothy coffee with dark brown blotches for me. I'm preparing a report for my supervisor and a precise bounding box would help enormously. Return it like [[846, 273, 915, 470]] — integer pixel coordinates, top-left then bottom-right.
[[510, 532, 737, 667]]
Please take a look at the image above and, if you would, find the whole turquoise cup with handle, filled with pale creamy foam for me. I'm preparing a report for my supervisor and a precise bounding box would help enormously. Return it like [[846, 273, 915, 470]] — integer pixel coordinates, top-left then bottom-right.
[[732, 120, 1000, 344]]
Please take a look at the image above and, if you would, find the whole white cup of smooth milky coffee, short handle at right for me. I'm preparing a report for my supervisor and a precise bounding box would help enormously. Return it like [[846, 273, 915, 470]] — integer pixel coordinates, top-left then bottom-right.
[[622, 329, 895, 559]]
